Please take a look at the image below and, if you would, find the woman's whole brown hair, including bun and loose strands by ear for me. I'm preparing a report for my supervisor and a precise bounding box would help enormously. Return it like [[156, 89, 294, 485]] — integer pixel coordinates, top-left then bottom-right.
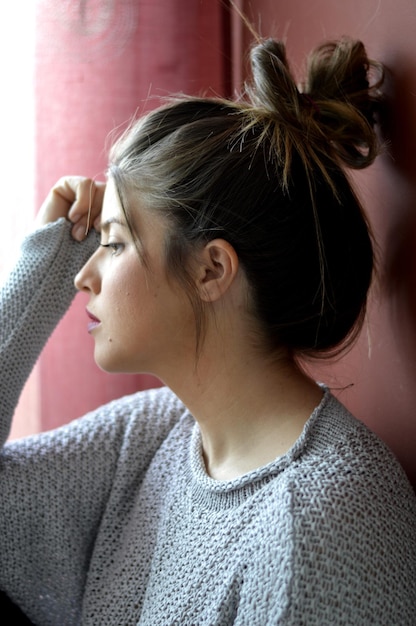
[[108, 38, 383, 357]]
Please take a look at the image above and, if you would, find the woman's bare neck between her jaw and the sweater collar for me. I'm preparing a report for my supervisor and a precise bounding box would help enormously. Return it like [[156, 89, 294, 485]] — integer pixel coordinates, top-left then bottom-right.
[[159, 336, 322, 480]]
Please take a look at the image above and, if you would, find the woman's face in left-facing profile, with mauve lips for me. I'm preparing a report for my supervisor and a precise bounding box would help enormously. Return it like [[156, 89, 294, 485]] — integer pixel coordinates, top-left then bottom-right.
[[75, 180, 195, 380]]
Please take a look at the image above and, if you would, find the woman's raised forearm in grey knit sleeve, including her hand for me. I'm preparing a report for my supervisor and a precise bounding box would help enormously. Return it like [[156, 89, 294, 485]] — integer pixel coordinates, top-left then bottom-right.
[[0, 177, 104, 444]]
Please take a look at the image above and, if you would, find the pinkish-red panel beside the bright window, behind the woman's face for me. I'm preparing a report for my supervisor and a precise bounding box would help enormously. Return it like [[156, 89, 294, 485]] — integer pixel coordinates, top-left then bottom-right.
[[35, 0, 229, 429]]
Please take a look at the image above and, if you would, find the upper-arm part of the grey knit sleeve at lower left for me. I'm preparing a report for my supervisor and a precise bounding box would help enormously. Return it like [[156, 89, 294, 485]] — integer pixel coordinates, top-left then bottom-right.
[[0, 388, 183, 626]]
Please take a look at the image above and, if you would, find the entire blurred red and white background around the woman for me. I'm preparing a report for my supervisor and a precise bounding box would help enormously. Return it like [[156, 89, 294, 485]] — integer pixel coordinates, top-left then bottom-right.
[[0, 0, 416, 485]]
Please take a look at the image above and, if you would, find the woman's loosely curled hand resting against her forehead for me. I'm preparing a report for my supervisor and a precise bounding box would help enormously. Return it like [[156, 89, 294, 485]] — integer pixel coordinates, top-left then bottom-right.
[[35, 176, 105, 241]]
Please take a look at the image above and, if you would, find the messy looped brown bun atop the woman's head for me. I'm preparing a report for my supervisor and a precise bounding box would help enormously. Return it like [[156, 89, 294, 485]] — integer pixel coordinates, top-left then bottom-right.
[[247, 37, 383, 169]]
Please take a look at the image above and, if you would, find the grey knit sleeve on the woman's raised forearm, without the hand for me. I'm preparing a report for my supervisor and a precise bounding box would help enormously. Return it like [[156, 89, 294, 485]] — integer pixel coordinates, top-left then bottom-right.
[[0, 219, 98, 445]]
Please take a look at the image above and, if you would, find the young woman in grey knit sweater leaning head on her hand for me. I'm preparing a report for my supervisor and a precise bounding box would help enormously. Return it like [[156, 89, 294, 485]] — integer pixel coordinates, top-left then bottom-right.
[[0, 39, 416, 626]]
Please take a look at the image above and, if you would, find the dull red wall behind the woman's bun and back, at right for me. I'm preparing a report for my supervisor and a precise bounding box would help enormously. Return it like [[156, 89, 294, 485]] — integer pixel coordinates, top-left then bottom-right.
[[243, 0, 416, 485]]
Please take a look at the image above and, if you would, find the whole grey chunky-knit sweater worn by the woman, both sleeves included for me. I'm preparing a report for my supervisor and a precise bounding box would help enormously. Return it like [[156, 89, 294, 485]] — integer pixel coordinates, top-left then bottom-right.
[[0, 220, 416, 626]]
